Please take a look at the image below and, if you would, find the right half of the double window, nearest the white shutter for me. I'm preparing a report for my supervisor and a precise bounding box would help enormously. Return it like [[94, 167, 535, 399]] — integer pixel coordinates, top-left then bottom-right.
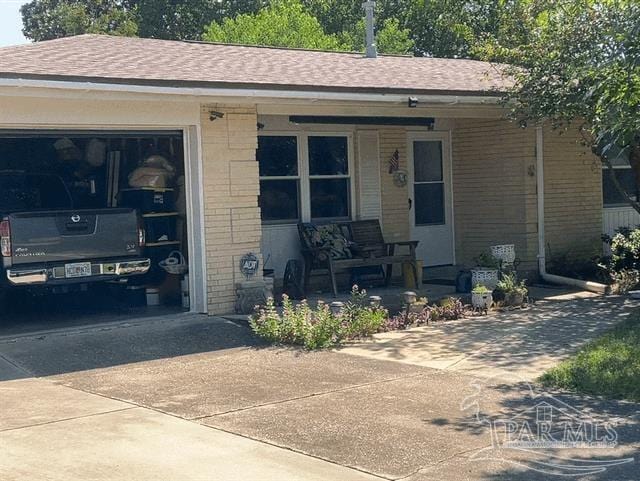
[[308, 136, 351, 220]]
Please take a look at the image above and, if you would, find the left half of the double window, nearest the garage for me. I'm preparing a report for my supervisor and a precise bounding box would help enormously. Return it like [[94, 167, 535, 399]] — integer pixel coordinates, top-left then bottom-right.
[[257, 135, 300, 223]]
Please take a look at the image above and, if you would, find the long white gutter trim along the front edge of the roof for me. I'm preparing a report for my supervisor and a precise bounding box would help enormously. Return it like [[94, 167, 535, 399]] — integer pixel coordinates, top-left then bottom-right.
[[0, 78, 500, 105]]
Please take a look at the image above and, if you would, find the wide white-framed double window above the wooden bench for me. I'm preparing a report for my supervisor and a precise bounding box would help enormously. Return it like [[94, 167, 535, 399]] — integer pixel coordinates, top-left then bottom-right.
[[257, 134, 351, 223]]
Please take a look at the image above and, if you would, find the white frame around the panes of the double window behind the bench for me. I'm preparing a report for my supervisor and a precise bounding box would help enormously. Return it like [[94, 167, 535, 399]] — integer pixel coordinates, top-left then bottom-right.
[[258, 130, 356, 226]]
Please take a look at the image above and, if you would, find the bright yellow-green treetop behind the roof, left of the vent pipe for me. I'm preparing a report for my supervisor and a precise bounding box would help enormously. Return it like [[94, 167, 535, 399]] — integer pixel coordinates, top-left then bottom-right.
[[203, 0, 348, 50]]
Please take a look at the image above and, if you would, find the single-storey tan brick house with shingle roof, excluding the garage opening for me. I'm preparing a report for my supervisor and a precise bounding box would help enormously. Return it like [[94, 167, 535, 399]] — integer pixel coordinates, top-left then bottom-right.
[[0, 35, 603, 314]]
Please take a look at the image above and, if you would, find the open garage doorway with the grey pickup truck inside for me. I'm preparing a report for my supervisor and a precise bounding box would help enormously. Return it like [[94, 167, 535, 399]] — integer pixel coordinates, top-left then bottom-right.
[[0, 130, 190, 334]]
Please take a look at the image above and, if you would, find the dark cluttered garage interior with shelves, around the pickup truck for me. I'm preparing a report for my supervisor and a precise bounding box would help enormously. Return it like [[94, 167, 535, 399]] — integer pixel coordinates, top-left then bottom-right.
[[0, 131, 189, 308]]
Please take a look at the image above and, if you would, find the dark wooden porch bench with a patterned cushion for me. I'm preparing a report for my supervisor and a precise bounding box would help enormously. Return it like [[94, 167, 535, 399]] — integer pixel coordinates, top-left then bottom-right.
[[298, 220, 418, 296]]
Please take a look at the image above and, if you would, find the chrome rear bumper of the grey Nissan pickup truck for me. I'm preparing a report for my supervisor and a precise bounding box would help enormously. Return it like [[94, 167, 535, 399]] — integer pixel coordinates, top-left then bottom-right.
[[7, 259, 151, 286]]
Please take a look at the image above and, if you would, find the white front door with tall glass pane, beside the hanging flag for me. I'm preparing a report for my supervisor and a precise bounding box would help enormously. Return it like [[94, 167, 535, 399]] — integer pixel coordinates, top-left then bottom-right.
[[409, 132, 454, 266]]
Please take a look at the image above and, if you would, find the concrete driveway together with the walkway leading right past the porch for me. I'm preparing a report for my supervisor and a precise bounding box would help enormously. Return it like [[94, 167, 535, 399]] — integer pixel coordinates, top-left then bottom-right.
[[0, 299, 640, 481]]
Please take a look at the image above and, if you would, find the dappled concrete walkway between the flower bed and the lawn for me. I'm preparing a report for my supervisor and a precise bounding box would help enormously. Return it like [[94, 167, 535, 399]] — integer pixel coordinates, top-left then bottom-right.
[[340, 297, 640, 381]]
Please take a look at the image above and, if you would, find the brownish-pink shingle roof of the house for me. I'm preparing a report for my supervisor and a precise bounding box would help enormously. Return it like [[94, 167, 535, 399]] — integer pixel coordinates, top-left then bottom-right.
[[0, 35, 508, 95]]
